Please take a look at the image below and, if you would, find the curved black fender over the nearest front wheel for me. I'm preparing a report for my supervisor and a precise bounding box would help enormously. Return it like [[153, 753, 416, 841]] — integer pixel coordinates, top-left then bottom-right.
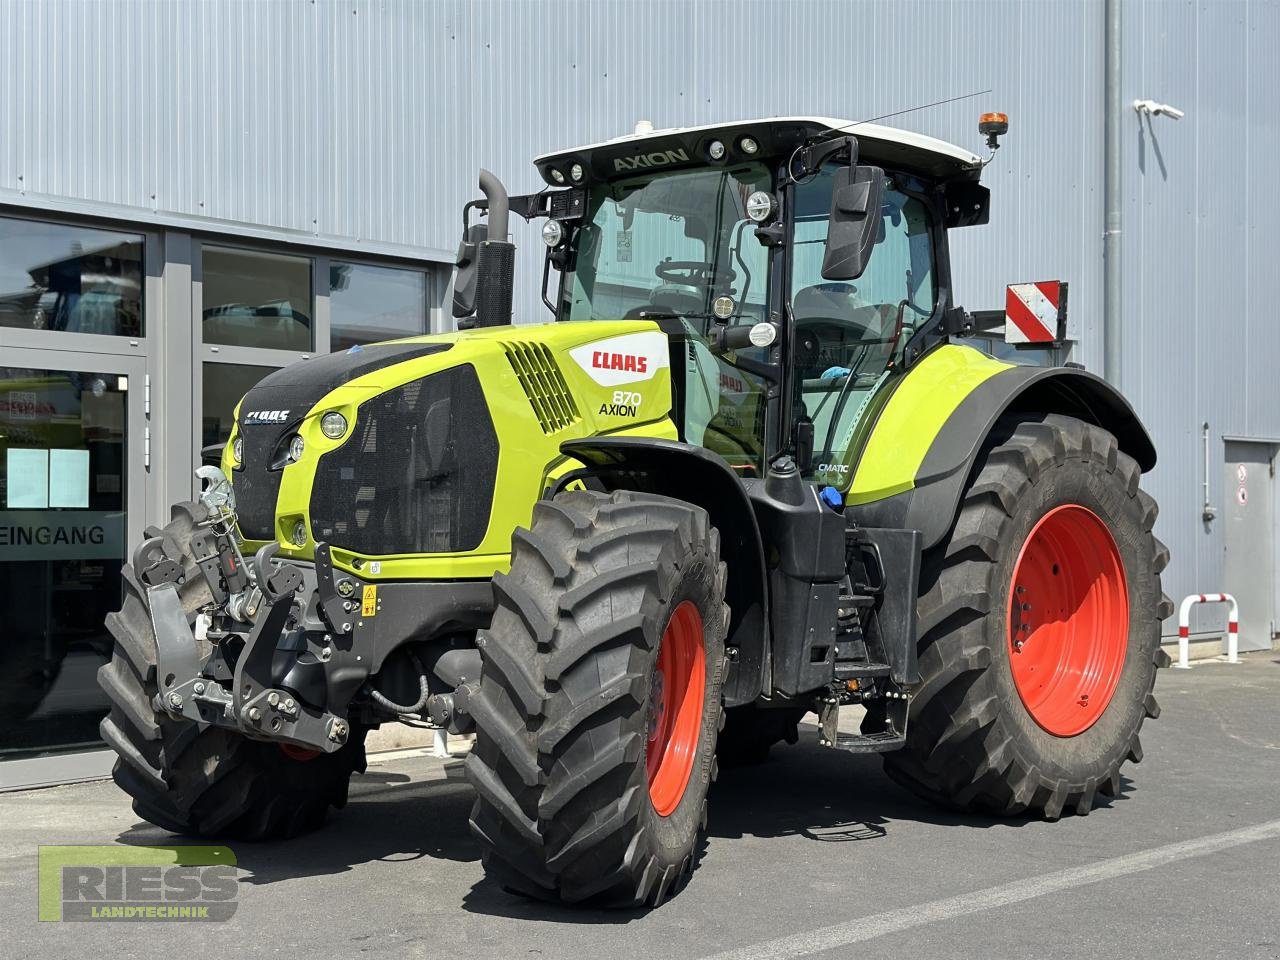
[[561, 436, 769, 707]]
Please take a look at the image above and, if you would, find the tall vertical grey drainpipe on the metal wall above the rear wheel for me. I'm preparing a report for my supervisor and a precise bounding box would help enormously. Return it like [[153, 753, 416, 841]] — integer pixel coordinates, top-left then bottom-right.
[[1102, 0, 1123, 388]]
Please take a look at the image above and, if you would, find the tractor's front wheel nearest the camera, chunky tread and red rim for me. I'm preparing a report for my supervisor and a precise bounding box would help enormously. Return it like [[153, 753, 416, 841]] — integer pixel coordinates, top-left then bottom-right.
[[466, 490, 728, 906]]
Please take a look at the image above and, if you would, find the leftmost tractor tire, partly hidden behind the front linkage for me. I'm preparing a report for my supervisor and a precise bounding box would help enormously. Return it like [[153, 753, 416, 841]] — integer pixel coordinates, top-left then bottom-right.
[[97, 503, 365, 840]]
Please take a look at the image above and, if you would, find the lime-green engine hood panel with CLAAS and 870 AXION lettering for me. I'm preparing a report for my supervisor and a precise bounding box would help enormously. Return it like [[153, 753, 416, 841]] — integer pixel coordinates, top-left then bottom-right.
[[223, 321, 677, 580]]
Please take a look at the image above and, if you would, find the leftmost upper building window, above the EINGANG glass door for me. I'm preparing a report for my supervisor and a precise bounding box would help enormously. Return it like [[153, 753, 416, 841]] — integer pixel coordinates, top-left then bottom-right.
[[0, 218, 143, 337]]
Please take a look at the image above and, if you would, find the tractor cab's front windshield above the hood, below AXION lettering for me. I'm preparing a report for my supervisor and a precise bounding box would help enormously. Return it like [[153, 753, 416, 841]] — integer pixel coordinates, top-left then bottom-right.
[[561, 164, 771, 335]]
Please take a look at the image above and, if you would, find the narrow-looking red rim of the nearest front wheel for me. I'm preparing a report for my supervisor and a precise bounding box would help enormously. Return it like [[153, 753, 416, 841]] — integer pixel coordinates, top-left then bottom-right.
[[645, 600, 707, 817]]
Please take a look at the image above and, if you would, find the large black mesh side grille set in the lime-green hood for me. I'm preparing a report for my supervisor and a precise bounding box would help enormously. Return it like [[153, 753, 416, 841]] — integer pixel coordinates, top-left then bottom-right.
[[311, 365, 498, 557]]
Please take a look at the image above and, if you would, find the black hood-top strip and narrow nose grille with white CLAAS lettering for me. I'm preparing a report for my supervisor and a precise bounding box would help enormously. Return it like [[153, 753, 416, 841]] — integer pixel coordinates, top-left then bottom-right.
[[231, 343, 449, 540]]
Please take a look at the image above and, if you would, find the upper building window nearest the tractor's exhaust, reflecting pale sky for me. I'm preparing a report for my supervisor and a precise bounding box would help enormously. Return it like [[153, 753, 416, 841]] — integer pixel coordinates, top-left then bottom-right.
[[329, 261, 428, 351]]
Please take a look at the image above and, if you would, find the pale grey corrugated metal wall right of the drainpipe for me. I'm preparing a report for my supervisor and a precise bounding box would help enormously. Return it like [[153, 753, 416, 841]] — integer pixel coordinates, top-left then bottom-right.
[[1121, 0, 1280, 627]]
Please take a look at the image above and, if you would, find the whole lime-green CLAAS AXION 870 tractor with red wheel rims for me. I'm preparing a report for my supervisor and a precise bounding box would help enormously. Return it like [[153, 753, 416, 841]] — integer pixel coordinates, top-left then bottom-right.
[[100, 115, 1170, 905]]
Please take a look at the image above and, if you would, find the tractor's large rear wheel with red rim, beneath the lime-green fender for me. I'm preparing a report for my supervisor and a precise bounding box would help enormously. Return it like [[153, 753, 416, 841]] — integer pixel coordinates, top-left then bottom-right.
[[868, 415, 1172, 819]]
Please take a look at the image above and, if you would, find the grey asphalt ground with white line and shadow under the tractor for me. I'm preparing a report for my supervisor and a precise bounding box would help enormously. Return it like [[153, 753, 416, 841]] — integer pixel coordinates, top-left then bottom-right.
[[0, 654, 1280, 960]]
